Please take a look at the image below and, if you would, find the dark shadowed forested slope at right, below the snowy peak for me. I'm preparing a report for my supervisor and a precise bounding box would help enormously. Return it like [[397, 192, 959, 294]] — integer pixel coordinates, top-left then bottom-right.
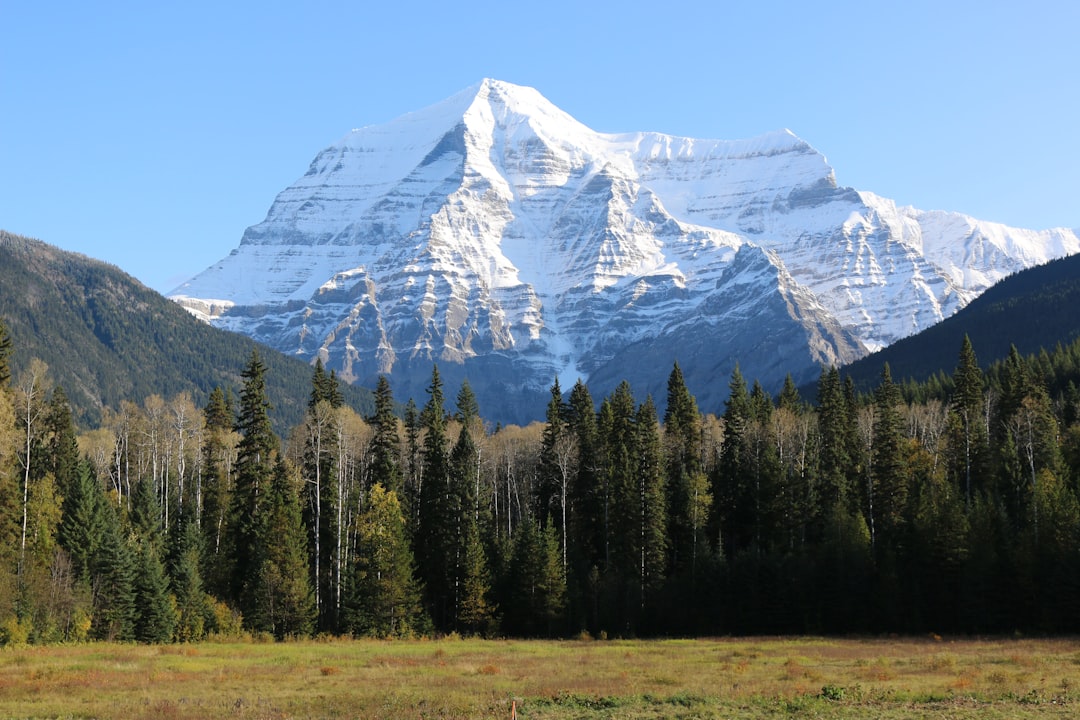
[[842, 255, 1080, 390]]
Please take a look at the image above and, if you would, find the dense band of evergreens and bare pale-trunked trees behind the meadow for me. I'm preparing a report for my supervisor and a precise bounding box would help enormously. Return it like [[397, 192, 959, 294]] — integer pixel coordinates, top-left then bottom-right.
[[0, 317, 1080, 643]]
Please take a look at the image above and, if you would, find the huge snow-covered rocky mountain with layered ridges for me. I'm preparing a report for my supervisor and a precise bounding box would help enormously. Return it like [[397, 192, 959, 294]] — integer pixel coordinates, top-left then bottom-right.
[[171, 80, 1080, 422]]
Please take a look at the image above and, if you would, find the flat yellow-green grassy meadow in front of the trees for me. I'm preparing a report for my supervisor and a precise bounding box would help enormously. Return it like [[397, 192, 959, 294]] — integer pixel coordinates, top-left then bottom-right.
[[0, 638, 1080, 720]]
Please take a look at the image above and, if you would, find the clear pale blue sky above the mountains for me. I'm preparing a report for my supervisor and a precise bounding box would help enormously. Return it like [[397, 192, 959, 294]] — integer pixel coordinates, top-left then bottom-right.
[[0, 0, 1080, 291]]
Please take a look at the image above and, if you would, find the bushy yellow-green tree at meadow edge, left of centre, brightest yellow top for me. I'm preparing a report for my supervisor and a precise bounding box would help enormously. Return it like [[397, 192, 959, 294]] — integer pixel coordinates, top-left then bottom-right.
[[345, 483, 428, 637]]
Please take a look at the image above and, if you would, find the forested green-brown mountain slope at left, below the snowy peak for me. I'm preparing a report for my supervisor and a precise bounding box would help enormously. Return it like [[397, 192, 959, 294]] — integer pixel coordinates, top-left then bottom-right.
[[0, 231, 368, 432]]
